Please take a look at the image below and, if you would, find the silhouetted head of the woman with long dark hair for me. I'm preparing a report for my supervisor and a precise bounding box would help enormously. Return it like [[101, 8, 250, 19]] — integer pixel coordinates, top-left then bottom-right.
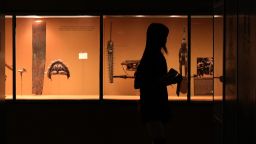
[[146, 23, 169, 53]]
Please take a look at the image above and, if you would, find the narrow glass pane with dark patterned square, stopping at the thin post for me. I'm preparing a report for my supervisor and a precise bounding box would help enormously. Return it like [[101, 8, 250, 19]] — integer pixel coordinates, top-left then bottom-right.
[[191, 16, 216, 101]]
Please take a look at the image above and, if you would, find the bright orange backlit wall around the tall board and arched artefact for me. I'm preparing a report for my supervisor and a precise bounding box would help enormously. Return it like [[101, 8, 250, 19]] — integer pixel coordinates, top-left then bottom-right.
[[5, 17, 100, 99]]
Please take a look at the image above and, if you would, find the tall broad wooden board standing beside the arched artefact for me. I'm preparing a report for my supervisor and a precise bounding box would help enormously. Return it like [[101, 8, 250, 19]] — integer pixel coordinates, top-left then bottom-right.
[[32, 20, 46, 95]]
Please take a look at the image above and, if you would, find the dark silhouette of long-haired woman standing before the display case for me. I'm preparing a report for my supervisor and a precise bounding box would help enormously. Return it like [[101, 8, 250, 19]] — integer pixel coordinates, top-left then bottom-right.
[[135, 23, 180, 144]]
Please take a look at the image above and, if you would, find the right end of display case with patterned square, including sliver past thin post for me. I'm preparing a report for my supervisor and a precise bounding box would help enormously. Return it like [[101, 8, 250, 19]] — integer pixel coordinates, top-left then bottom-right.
[[190, 15, 223, 101]]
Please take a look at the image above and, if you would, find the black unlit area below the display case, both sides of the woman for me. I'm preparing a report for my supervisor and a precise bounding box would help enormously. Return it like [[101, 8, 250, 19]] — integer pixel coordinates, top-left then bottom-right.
[[1, 100, 217, 144]]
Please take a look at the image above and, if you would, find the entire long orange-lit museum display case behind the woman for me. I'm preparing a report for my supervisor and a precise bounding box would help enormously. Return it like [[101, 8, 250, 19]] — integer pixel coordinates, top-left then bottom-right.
[[2, 15, 223, 101]]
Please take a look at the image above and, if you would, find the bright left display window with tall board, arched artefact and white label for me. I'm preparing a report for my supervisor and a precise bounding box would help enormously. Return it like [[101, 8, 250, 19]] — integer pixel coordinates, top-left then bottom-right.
[[6, 16, 100, 100]]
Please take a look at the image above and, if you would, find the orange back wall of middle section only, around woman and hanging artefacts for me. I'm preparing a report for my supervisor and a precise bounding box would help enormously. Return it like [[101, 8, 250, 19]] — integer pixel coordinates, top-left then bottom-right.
[[104, 17, 187, 95]]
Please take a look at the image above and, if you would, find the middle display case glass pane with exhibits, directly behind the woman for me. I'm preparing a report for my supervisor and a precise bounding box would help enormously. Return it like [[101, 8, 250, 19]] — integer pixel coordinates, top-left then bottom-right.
[[103, 15, 188, 100]]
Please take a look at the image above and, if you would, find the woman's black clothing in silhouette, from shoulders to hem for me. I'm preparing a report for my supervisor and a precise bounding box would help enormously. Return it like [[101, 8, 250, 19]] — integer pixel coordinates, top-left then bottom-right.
[[135, 51, 169, 122]]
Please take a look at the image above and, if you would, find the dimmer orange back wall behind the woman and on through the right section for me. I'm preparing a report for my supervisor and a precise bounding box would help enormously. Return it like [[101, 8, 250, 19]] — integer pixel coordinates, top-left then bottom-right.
[[104, 17, 222, 96]]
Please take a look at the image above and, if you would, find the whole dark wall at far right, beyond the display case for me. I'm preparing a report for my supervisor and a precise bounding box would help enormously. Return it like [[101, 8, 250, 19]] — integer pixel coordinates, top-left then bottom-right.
[[224, 0, 256, 144]]
